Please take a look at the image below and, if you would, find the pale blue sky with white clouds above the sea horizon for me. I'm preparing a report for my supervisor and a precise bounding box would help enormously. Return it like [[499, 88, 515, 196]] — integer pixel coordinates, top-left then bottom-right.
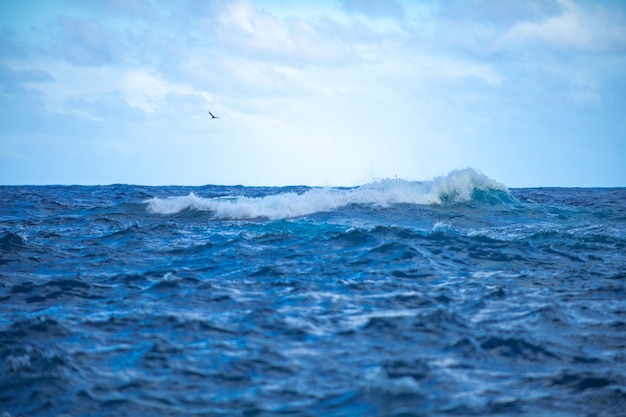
[[0, 0, 626, 187]]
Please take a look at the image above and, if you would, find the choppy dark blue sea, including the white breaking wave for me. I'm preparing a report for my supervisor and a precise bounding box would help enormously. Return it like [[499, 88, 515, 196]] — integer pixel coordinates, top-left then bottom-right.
[[0, 169, 626, 417]]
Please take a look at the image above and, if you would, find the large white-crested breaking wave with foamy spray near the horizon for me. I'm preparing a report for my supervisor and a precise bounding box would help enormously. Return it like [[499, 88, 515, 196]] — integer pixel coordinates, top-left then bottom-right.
[[144, 168, 512, 220]]
